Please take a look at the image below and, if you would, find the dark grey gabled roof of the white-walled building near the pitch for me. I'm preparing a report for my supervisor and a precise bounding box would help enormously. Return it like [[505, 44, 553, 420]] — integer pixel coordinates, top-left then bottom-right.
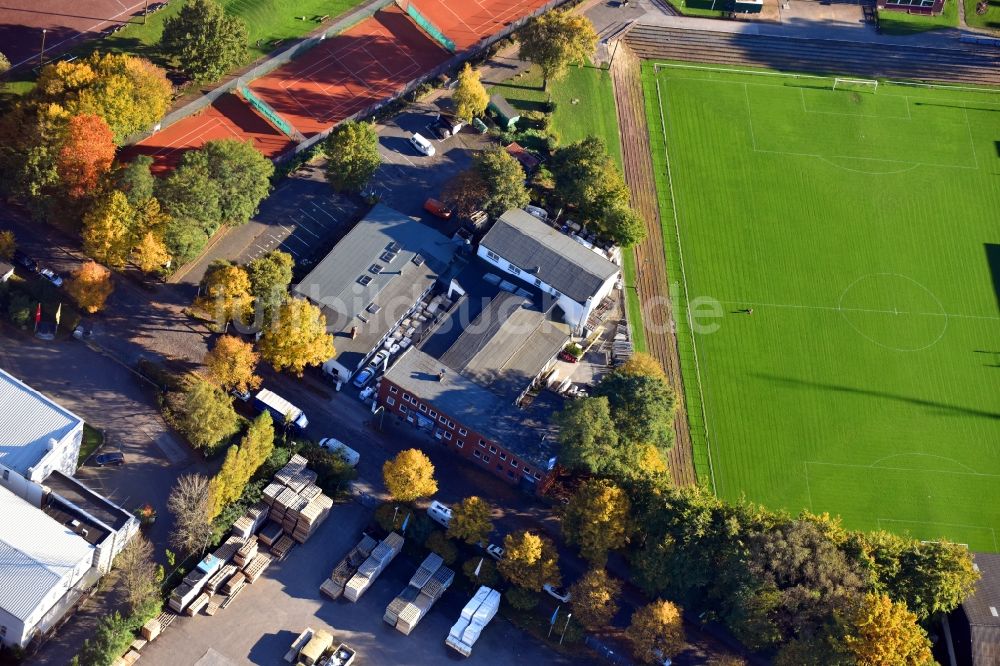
[[480, 208, 619, 303]]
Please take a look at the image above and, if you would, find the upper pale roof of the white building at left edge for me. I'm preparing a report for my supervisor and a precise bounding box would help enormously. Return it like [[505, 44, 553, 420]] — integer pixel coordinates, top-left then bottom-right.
[[0, 370, 83, 475]]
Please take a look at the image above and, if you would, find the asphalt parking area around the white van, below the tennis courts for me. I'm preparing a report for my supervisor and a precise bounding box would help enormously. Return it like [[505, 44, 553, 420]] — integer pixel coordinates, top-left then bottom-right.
[[372, 104, 489, 228]]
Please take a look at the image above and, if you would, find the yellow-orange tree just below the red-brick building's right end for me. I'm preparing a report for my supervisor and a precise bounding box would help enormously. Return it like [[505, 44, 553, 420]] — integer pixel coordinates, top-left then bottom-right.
[[561, 479, 631, 566]]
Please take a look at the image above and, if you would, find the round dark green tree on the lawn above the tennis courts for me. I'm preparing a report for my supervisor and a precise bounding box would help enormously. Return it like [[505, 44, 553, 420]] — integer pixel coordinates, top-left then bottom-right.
[[160, 0, 249, 81]]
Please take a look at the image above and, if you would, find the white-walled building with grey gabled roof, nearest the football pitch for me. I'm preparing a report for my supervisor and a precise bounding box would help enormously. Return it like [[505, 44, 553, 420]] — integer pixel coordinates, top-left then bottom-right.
[[477, 208, 621, 335]]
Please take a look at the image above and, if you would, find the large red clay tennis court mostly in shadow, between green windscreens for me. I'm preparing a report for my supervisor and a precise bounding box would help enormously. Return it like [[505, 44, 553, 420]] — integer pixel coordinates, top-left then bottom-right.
[[250, 7, 449, 137]]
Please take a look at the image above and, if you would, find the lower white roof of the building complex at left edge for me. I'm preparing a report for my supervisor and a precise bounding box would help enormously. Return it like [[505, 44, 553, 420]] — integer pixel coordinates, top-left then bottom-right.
[[0, 486, 94, 620]]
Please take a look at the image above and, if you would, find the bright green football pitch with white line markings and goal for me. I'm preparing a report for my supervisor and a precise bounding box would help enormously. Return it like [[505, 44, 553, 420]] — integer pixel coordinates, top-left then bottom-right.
[[643, 63, 1000, 551]]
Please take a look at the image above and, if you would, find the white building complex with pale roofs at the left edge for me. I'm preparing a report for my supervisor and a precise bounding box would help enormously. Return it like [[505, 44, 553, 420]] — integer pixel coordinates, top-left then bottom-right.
[[0, 370, 139, 647]]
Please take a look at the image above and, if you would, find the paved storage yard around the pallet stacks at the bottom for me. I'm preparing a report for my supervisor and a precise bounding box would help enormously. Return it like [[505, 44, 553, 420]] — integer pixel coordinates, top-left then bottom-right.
[[142, 502, 586, 666]]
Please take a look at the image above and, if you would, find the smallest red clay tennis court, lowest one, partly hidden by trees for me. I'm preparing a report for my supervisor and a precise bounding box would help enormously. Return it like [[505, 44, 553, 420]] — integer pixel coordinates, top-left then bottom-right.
[[122, 94, 292, 172]]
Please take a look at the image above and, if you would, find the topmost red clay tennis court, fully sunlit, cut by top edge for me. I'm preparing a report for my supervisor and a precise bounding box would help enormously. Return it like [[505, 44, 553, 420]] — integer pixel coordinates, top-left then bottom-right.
[[401, 0, 546, 51]]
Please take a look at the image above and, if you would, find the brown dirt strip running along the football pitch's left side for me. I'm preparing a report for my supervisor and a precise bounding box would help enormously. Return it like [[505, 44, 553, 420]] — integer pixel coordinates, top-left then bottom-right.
[[611, 43, 697, 486]]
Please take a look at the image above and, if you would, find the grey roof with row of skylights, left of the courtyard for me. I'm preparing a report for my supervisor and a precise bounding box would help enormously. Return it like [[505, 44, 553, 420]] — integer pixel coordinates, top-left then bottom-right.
[[293, 204, 459, 368]]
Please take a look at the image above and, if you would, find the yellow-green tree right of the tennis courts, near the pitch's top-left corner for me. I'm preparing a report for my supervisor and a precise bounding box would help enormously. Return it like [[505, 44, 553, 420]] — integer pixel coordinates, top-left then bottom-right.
[[517, 10, 597, 90]]
